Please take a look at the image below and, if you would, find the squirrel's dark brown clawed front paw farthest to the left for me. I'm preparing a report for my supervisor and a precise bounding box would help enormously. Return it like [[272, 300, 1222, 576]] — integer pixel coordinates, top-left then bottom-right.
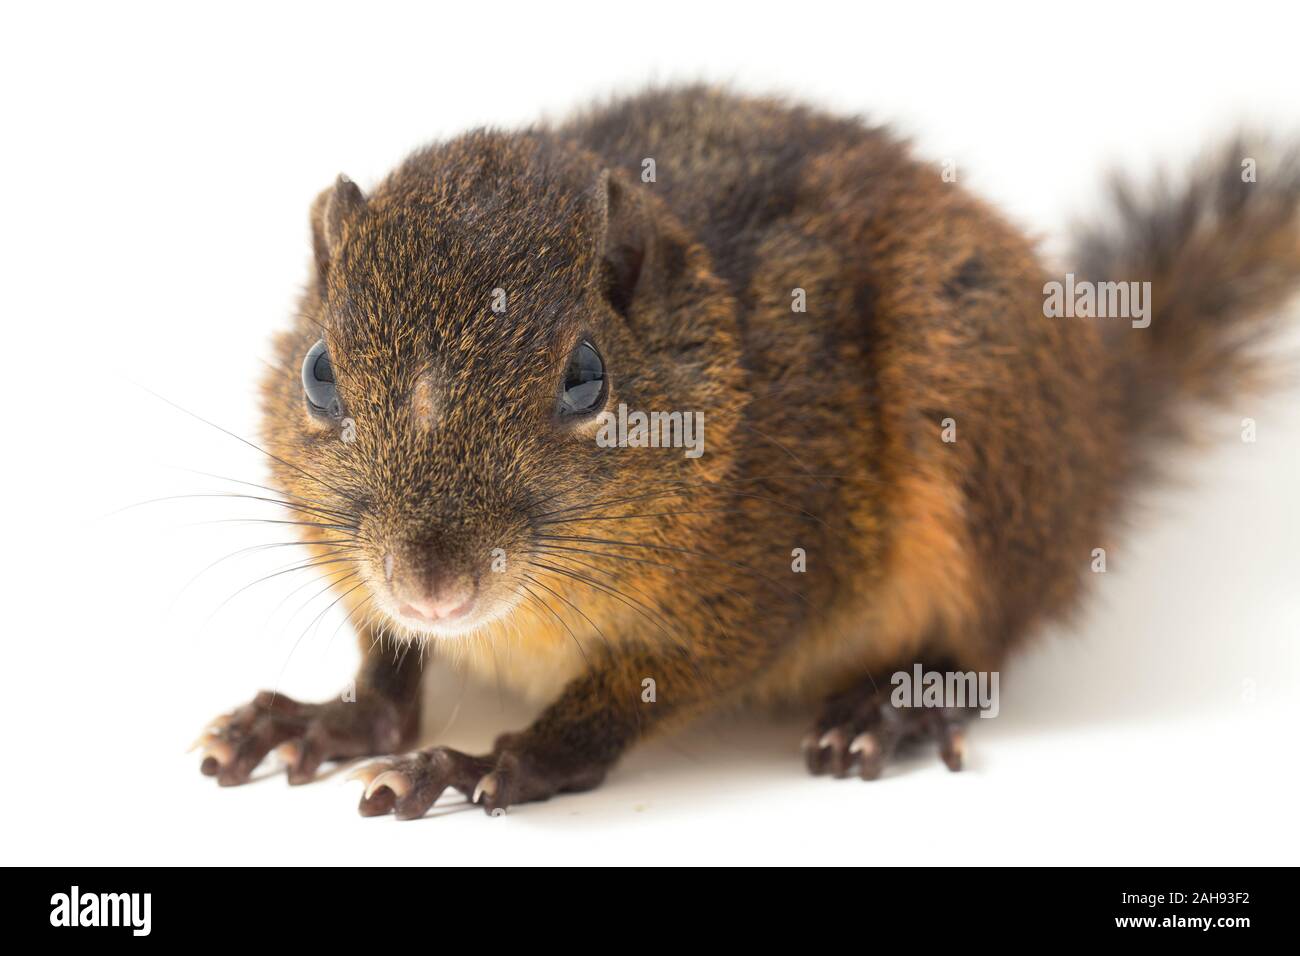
[[191, 691, 411, 787]]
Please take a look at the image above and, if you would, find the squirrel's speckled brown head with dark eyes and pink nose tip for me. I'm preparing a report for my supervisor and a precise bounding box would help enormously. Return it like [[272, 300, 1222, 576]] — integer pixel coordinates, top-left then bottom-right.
[[264, 131, 745, 637]]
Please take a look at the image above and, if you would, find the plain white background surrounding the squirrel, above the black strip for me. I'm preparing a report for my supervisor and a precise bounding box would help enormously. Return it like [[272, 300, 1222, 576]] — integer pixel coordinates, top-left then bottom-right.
[[0, 0, 1300, 865]]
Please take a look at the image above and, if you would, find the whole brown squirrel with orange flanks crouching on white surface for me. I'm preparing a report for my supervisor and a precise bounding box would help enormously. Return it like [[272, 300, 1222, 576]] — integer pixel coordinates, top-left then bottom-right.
[[199, 86, 1300, 818]]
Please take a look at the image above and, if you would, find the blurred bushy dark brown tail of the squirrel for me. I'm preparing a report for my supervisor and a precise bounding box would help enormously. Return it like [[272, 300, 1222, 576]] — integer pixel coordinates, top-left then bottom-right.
[[1075, 138, 1300, 447]]
